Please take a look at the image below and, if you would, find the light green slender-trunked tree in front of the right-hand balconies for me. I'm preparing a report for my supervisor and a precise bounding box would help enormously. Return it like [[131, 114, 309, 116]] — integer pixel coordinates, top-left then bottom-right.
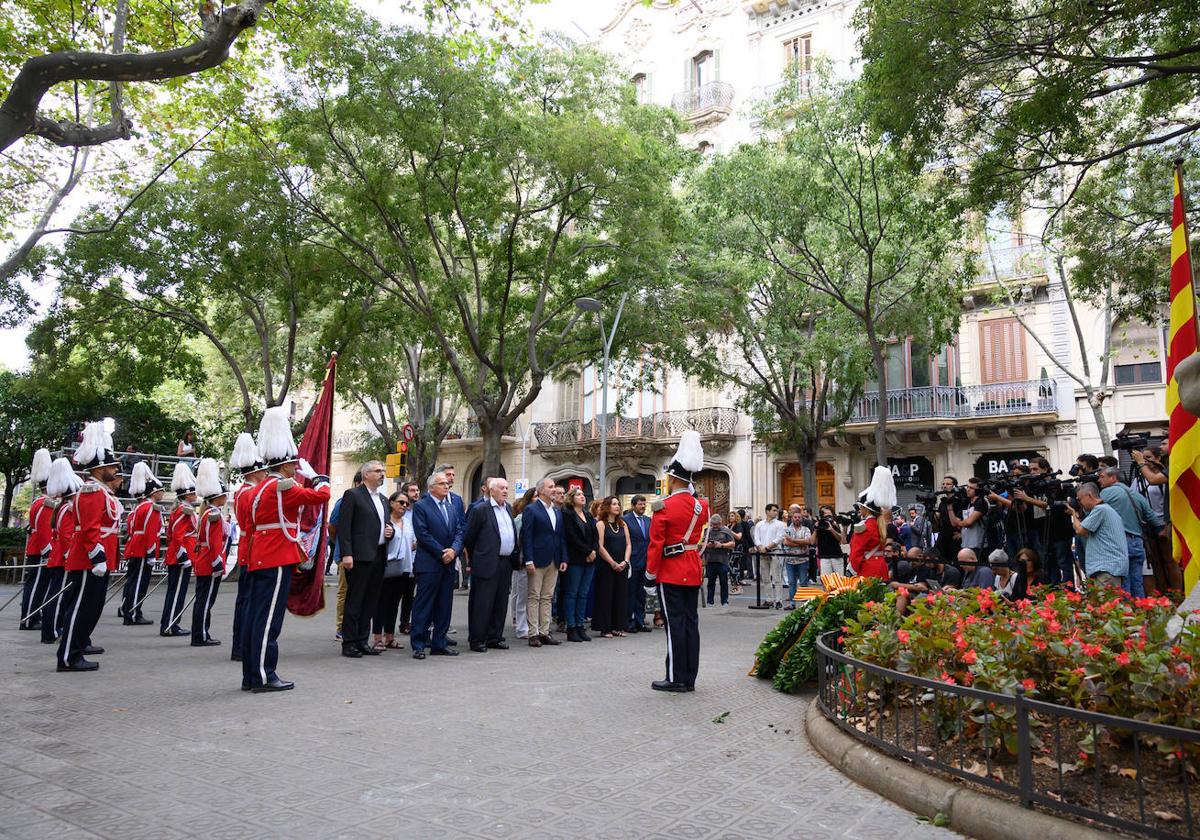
[[696, 83, 970, 463]]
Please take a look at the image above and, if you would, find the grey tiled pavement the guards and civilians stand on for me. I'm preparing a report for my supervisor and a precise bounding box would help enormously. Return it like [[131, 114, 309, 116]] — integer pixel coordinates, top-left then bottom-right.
[[0, 587, 955, 840]]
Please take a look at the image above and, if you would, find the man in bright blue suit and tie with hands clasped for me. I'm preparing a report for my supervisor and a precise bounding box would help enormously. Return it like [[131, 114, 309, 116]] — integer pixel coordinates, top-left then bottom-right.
[[412, 473, 463, 659]]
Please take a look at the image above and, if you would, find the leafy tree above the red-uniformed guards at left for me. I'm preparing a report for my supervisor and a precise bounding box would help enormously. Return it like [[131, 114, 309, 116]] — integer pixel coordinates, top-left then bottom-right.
[[49, 146, 373, 430]]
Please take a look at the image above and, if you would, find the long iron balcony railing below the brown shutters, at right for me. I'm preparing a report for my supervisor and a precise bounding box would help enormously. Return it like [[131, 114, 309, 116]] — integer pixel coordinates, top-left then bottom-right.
[[847, 379, 1058, 424]]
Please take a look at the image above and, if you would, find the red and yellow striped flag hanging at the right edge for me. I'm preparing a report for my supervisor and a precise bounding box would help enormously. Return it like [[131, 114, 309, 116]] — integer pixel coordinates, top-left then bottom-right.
[[1166, 161, 1200, 593]]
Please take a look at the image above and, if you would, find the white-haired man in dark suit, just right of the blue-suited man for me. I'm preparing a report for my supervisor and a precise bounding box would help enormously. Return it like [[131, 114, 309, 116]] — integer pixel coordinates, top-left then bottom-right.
[[462, 478, 517, 653]]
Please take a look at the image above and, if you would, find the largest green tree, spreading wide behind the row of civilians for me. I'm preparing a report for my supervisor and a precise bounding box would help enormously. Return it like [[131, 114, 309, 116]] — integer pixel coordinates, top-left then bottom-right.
[[280, 26, 689, 475]]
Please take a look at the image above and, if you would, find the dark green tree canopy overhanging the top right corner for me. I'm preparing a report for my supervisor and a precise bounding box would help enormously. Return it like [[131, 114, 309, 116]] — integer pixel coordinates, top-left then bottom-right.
[[858, 0, 1200, 205]]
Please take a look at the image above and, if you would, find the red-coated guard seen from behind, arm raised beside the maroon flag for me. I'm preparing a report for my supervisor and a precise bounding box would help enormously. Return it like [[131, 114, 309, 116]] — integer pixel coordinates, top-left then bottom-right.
[[241, 406, 329, 692]]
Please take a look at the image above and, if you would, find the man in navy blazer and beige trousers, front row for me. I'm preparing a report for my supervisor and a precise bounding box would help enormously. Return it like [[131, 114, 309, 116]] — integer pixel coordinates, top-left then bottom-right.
[[521, 479, 566, 648]]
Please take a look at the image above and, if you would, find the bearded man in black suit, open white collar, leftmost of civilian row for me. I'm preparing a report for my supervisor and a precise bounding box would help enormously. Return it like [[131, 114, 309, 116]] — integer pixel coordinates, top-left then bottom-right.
[[337, 461, 392, 659]]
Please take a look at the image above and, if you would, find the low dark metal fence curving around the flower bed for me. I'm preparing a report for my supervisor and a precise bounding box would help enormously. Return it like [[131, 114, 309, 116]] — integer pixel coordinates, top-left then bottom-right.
[[817, 631, 1200, 838]]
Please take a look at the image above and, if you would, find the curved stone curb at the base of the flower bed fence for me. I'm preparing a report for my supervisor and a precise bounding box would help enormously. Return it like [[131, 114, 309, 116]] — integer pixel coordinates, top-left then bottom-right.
[[804, 700, 1114, 840]]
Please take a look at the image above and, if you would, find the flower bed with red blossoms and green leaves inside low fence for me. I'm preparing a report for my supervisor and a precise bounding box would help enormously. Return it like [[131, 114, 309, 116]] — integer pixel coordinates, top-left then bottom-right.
[[826, 589, 1200, 836]]
